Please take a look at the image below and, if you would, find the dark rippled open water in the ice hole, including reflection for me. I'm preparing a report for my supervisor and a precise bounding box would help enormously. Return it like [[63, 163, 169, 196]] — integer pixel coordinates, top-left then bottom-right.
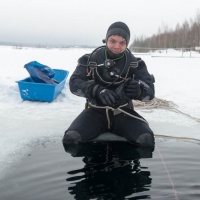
[[0, 137, 200, 200]]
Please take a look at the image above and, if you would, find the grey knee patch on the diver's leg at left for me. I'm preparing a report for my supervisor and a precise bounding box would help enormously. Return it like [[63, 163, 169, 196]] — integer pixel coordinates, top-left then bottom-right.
[[63, 130, 81, 145]]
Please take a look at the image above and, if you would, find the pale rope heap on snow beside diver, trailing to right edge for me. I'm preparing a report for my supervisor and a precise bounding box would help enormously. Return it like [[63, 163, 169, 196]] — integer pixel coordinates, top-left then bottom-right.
[[133, 98, 200, 123]]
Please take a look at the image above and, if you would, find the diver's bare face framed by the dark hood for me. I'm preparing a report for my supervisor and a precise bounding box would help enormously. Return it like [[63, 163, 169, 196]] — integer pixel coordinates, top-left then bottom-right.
[[107, 35, 127, 54]]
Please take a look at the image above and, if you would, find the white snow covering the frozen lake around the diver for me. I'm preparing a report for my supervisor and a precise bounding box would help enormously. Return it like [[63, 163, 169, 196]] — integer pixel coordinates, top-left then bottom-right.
[[0, 46, 200, 178]]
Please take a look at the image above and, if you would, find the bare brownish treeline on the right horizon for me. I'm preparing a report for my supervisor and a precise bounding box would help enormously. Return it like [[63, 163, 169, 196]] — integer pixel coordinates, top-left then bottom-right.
[[129, 11, 200, 52]]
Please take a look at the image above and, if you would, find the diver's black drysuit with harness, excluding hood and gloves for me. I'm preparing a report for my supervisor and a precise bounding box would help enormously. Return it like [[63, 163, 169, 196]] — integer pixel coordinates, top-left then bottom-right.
[[66, 46, 154, 143]]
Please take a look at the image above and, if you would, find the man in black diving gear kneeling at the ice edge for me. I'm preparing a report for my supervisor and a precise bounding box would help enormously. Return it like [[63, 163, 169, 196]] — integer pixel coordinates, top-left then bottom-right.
[[63, 22, 154, 146]]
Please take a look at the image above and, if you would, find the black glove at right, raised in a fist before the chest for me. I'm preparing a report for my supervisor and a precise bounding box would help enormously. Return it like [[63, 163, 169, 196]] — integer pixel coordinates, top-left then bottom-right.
[[124, 79, 141, 99]]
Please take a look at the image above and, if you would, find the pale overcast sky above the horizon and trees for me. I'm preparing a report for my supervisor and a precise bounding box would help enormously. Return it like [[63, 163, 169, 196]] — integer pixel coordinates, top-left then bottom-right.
[[0, 0, 200, 46]]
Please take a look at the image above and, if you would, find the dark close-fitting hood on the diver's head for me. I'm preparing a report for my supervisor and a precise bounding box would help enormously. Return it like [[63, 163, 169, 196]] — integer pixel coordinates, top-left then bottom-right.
[[106, 22, 130, 46]]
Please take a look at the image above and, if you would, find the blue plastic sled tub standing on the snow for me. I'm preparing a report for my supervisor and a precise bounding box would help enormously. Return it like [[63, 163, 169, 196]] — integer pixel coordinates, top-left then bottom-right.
[[16, 69, 69, 102]]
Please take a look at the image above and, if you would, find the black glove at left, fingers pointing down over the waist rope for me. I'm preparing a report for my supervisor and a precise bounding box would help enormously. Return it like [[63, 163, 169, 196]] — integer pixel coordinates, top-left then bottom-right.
[[97, 89, 117, 106]]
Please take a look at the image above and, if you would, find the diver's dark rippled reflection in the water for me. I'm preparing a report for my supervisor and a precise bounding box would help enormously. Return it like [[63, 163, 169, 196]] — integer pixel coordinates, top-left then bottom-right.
[[64, 142, 153, 200]]
